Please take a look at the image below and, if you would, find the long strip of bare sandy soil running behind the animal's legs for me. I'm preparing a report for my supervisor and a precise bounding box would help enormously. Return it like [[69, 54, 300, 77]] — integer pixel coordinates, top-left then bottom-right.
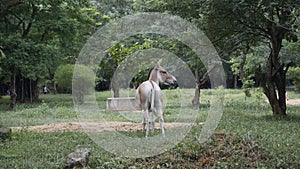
[[11, 122, 192, 133]]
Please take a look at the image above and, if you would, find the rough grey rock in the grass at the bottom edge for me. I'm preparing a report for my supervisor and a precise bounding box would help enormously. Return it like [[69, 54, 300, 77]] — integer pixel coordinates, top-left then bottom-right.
[[65, 148, 91, 169]]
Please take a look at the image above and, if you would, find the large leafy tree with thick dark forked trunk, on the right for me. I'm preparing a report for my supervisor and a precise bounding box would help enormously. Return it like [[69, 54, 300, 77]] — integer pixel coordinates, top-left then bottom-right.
[[205, 0, 300, 115]]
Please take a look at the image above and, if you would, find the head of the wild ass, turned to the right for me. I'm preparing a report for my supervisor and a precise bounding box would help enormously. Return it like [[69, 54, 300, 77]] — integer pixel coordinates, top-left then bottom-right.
[[154, 60, 178, 87]]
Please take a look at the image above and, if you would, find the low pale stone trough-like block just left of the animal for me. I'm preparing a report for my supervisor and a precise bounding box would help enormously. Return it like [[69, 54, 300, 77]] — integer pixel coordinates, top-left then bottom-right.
[[106, 97, 140, 111]]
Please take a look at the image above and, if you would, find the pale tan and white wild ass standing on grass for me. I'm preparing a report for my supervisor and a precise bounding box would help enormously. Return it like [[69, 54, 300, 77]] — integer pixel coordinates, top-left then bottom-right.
[[136, 61, 177, 137]]
